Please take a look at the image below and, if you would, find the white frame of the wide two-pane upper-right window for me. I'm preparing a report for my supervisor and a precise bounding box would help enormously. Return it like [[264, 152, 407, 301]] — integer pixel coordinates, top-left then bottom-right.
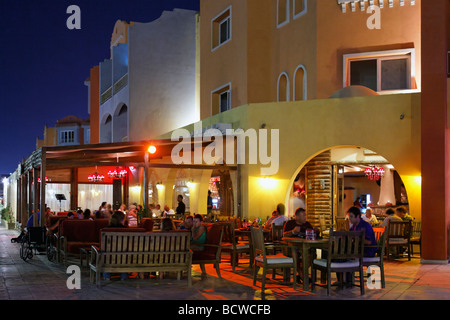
[[343, 49, 419, 94]]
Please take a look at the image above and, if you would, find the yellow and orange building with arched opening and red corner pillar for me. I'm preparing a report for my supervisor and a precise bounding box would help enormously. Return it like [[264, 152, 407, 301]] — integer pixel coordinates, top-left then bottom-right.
[[163, 0, 449, 262]]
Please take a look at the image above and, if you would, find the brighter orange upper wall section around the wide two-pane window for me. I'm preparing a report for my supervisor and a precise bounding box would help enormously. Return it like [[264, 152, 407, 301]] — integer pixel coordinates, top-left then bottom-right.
[[316, 0, 421, 99]]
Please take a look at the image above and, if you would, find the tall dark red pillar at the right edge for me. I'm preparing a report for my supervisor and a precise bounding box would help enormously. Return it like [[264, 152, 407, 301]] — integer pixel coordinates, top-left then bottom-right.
[[421, 0, 450, 263]]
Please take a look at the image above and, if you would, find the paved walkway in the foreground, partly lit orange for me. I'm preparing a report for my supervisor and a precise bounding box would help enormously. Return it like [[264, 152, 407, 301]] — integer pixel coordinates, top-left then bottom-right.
[[0, 227, 450, 301]]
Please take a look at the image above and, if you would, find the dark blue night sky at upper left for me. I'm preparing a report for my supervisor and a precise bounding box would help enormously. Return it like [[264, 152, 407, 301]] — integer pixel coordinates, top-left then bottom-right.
[[0, 0, 200, 174]]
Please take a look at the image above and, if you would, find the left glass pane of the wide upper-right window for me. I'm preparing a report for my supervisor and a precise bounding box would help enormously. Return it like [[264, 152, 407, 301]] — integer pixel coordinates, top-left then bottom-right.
[[350, 60, 378, 91]]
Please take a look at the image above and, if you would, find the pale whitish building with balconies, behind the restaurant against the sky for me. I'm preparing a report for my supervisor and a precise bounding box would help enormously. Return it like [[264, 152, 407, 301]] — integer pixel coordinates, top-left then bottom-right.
[[86, 9, 199, 143]]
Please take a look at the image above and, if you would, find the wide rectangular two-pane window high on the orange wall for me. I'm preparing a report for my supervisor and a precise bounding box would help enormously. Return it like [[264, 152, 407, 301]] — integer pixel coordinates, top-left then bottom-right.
[[344, 49, 415, 92]]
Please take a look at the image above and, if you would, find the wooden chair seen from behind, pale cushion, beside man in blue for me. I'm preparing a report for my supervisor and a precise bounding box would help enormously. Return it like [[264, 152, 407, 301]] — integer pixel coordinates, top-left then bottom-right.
[[311, 230, 364, 295]]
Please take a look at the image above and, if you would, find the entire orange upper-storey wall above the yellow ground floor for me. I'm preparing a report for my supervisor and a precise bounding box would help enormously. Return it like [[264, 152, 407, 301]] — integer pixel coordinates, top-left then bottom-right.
[[200, 0, 421, 119]]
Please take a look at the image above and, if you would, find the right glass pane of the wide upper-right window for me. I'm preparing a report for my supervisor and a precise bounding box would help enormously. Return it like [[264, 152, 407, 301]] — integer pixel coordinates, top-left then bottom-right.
[[381, 59, 410, 90]]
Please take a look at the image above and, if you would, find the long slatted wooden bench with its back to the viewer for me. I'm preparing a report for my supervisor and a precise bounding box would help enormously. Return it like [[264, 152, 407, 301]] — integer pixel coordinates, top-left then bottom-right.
[[89, 229, 192, 287]]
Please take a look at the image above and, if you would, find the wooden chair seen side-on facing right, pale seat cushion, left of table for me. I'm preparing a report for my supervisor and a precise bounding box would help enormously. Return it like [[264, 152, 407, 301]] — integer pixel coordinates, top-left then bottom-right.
[[252, 228, 297, 292]]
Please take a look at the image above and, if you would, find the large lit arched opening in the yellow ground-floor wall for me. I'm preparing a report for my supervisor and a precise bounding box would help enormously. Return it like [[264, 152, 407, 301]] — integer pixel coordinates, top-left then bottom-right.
[[288, 147, 409, 230]]
